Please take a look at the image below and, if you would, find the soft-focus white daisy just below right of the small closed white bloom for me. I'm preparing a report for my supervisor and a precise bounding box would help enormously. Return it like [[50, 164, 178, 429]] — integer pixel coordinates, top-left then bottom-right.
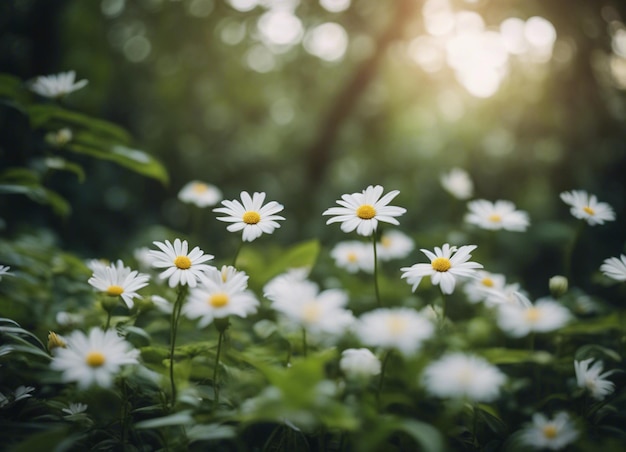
[[465, 199, 530, 231]]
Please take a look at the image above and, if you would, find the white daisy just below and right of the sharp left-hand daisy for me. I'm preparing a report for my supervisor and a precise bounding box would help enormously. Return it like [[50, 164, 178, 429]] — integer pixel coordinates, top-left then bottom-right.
[[183, 268, 259, 328]]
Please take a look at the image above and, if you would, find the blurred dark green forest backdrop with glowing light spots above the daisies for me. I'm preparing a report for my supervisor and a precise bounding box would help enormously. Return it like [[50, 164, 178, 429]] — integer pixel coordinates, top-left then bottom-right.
[[0, 0, 626, 294]]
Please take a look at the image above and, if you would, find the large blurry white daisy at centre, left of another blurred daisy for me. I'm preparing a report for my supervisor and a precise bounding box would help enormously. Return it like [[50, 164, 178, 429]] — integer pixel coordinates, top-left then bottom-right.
[[271, 280, 354, 336]]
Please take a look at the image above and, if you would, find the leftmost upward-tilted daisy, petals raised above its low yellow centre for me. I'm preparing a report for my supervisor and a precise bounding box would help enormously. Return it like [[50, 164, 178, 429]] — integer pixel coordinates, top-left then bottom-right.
[[87, 260, 150, 309]]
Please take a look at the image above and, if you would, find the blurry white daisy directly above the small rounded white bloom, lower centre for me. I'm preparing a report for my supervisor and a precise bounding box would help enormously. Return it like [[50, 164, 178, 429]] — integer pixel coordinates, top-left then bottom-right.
[[354, 308, 435, 355]]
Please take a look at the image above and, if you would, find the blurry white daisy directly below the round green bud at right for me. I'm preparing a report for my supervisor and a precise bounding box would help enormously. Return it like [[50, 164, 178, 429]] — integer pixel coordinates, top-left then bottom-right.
[[498, 292, 572, 337]]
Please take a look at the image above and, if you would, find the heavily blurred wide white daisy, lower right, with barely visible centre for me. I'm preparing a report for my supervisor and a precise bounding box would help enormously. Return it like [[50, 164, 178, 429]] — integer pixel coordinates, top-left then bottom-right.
[[422, 353, 506, 402]]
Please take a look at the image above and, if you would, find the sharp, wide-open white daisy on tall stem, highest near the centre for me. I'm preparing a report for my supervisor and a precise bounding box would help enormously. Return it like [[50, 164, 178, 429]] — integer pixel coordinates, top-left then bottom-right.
[[322, 185, 406, 236]]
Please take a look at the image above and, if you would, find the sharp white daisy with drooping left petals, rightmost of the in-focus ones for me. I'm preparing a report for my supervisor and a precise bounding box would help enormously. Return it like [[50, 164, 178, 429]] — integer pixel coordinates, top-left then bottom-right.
[[401, 243, 483, 294]]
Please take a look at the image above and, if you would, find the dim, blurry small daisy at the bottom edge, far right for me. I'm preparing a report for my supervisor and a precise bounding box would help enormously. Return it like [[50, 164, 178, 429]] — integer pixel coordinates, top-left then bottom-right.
[[518, 411, 578, 450]]
